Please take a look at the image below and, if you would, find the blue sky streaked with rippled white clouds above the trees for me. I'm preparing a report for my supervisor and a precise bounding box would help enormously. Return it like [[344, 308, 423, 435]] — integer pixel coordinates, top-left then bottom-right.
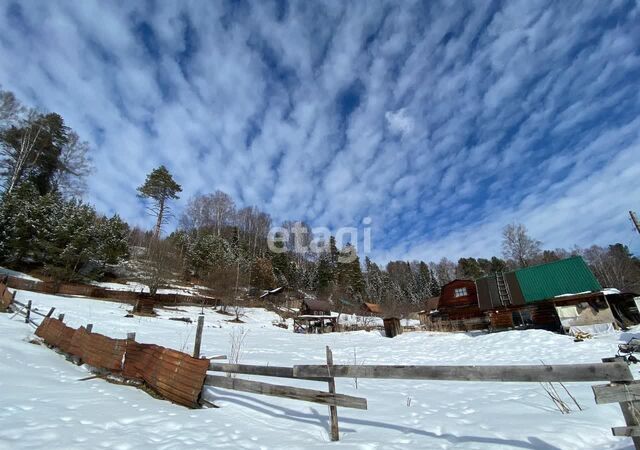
[[0, 0, 640, 262]]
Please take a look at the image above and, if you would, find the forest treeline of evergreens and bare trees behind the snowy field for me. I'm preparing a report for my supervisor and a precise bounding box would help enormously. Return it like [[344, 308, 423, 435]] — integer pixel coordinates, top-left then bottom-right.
[[0, 87, 640, 305]]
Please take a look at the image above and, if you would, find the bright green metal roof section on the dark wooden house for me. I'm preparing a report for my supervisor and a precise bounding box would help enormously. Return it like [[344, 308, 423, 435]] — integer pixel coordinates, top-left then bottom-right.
[[515, 256, 602, 303]]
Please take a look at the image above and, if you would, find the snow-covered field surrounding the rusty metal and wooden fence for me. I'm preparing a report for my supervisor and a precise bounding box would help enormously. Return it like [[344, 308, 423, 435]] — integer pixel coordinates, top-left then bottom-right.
[[0, 291, 637, 450]]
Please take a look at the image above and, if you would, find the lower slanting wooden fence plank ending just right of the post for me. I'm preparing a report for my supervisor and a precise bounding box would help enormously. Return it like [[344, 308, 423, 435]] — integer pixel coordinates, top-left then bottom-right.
[[204, 375, 367, 409]]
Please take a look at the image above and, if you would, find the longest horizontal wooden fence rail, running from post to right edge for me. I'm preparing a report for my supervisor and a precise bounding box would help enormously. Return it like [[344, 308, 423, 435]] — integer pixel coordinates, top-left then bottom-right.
[[293, 362, 633, 383]]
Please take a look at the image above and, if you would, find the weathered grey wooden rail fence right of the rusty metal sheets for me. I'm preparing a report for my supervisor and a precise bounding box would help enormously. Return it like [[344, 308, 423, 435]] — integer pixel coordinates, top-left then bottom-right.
[[205, 356, 640, 449]]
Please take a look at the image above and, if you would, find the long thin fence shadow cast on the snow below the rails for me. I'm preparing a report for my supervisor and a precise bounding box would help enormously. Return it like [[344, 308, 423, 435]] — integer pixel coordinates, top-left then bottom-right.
[[208, 387, 561, 450]]
